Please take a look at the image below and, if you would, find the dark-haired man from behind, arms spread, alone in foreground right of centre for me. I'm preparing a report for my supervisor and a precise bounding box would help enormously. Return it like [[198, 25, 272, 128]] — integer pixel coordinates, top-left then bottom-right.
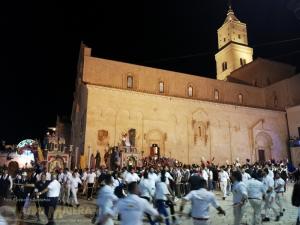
[[180, 176, 226, 225]]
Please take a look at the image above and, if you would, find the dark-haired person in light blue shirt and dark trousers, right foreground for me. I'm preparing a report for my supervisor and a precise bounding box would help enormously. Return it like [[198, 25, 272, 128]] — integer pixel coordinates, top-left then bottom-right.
[[231, 170, 248, 225]]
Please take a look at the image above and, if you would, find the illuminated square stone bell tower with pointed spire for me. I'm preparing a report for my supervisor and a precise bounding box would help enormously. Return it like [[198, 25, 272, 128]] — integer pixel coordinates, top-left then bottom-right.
[[215, 1, 253, 80]]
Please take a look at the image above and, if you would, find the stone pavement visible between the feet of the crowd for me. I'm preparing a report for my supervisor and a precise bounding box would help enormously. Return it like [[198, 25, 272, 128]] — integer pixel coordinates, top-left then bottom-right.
[[3, 184, 297, 225]]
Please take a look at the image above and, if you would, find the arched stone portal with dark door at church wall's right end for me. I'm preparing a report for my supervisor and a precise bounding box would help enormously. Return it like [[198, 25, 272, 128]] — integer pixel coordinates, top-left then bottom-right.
[[255, 131, 273, 161]]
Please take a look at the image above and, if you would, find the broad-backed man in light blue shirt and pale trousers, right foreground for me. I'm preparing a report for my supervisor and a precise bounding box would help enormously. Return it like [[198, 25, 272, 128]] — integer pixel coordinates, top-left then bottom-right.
[[245, 170, 266, 225]]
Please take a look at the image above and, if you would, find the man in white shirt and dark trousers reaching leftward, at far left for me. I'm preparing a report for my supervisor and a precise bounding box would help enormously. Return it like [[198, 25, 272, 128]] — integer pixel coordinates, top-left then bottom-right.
[[37, 174, 61, 225]]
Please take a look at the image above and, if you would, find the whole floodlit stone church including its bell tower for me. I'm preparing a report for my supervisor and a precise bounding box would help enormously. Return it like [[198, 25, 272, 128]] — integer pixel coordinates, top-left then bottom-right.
[[71, 8, 300, 167]]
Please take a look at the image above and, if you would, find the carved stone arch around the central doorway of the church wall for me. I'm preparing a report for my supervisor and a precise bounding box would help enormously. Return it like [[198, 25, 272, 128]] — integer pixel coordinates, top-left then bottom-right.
[[144, 129, 166, 156]]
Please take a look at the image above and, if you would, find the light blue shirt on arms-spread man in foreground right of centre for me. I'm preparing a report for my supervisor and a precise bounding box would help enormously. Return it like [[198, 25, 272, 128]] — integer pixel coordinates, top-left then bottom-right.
[[183, 188, 220, 218]]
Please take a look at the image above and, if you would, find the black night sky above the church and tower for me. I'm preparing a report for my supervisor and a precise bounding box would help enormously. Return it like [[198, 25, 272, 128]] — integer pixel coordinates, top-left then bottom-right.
[[0, 0, 300, 143]]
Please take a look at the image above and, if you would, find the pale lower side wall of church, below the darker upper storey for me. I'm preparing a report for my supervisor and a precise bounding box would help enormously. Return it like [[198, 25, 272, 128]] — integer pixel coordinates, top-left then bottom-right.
[[79, 84, 287, 166]]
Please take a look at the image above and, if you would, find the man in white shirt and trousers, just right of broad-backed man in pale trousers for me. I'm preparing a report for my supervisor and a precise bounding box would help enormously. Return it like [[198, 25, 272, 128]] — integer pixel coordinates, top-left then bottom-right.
[[262, 168, 280, 222]]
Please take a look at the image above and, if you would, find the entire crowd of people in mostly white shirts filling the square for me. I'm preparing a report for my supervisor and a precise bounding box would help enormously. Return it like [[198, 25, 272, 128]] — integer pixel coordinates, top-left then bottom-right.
[[0, 158, 300, 225]]
